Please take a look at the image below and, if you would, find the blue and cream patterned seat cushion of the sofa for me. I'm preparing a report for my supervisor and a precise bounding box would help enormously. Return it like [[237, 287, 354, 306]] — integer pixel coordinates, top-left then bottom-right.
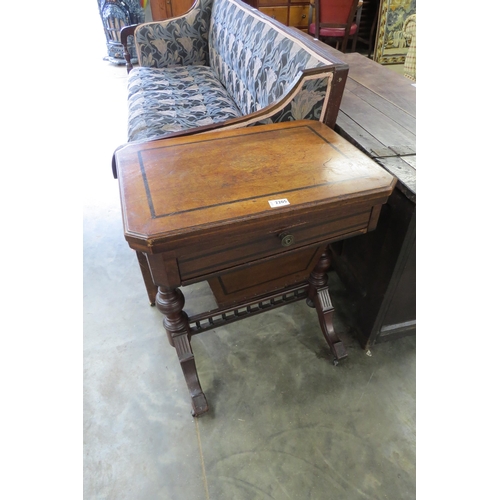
[[128, 66, 242, 141]]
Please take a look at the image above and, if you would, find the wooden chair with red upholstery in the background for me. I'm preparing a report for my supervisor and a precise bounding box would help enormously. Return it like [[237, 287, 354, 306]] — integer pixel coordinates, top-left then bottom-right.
[[308, 0, 363, 52]]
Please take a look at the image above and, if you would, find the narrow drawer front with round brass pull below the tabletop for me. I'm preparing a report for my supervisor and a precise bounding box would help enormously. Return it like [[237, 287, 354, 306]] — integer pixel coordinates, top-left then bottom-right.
[[177, 207, 372, 282]]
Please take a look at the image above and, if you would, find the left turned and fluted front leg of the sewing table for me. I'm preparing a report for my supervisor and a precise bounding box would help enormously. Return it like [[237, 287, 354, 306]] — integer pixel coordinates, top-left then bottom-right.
[[156, 286, 208, 417]]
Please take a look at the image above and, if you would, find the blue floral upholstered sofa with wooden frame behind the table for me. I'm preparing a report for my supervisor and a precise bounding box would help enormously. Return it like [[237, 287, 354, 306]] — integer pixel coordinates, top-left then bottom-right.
[[112, 0, 348, 176]]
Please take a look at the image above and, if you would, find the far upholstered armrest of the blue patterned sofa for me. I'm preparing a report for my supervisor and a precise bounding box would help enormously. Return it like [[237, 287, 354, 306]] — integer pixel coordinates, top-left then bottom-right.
[[134, 0, 212, 68]]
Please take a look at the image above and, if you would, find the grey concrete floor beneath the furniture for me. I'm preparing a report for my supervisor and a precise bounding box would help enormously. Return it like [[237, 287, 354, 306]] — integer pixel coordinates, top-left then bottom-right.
[[82, 8, 416, 500]]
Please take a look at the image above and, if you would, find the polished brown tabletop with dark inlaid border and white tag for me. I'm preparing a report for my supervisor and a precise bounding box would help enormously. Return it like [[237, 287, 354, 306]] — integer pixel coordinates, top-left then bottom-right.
[[116, 121, 396, 250]]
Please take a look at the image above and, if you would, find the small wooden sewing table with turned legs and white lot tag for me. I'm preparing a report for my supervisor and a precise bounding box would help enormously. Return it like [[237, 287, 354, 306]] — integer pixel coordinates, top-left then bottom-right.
[[115, 121, 395, 416]]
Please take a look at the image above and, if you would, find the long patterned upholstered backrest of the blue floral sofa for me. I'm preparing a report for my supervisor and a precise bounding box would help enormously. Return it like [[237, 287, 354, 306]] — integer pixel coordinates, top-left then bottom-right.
[[208, 0, 331, 115]]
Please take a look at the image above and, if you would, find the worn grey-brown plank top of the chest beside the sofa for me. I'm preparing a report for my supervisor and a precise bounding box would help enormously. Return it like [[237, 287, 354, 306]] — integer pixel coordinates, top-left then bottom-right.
[[331, 49, 417, 200]]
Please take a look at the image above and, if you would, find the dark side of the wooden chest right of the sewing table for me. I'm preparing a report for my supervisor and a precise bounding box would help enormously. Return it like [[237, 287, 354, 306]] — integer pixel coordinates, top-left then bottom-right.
[[332, 179, 416, 348]]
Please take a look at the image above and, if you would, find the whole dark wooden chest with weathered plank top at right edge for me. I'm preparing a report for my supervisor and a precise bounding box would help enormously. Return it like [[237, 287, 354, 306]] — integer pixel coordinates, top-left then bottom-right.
[[324, 51, 417, 348]]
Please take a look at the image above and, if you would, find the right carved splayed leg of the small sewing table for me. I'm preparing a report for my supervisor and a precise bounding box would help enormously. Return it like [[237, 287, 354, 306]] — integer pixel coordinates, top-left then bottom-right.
[[307, 248, 347, 364]]
